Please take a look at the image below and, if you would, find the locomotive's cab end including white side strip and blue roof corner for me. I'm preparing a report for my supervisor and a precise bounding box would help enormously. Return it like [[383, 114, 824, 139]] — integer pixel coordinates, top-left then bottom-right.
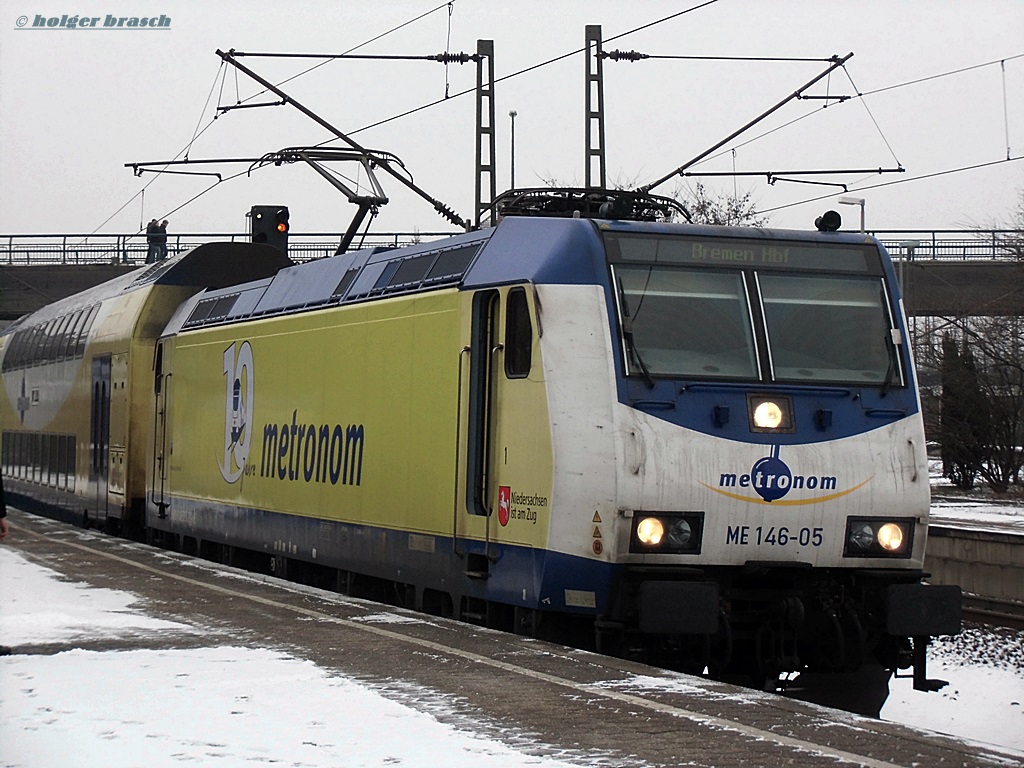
[[466, 219, 959, 692]]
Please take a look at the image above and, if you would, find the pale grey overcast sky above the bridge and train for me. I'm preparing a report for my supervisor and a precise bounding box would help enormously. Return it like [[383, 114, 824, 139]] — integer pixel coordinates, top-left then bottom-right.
[[0, 0, 1024, 233]]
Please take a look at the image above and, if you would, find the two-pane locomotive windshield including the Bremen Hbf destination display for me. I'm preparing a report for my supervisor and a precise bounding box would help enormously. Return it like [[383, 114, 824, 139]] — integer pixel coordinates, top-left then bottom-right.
[[605, 232, 902, 386]]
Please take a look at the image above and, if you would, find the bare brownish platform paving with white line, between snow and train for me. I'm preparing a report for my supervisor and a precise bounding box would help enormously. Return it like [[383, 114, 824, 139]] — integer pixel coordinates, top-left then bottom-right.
[[3, 510, 1021, 768]]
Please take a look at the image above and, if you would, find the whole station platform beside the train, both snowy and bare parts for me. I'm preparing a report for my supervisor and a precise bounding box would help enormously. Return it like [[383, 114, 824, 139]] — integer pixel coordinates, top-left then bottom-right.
[[0, 510, 1024, 768]]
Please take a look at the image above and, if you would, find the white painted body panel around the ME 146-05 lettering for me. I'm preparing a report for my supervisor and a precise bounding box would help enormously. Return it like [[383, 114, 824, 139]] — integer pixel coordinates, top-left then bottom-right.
[[538, 286, 929, 568]]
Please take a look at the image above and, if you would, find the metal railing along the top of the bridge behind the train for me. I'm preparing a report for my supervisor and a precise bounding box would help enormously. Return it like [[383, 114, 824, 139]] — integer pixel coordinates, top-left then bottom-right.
[[0, 229, 1024, 266]]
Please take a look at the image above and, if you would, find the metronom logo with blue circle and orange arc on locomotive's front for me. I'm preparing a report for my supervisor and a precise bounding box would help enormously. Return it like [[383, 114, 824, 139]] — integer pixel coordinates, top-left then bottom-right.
[[700, 445, 874, 506]]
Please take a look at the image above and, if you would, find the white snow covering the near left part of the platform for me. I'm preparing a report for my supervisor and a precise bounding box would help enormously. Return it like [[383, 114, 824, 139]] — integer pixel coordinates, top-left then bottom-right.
[[0, 547, 609, 768]]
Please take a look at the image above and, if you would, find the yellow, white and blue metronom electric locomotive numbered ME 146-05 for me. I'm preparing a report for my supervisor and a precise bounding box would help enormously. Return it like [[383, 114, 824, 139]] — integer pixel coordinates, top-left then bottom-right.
[[3, 204, 959, 713]]
